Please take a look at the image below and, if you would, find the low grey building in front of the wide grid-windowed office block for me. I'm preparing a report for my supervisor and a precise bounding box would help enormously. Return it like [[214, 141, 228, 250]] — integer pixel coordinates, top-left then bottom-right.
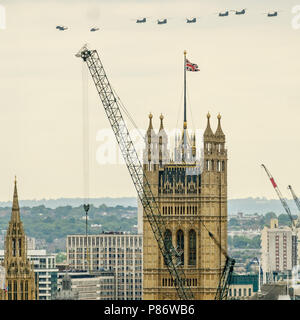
[[54, 270, 116, 300]]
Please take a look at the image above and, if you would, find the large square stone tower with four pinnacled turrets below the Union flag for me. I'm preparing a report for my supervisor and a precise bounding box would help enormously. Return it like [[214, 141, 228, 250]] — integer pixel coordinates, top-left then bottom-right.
[[143, 114, 227, 300]]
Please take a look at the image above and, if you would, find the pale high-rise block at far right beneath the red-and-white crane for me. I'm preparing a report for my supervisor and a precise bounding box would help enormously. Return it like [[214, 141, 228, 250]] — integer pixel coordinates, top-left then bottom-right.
[[261, 219, 297, 276]]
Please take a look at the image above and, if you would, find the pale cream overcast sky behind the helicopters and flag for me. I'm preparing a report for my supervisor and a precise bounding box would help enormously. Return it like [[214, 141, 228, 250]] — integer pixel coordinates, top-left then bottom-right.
[[0, 0, 300, 201]]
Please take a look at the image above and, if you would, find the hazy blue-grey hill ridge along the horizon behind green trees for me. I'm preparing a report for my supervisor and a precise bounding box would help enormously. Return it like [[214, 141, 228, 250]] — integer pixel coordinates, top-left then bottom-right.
[[0, 197, 298, 215]]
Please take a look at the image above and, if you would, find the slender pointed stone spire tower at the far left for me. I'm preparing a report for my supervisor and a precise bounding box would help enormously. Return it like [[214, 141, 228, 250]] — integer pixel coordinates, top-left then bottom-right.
[[4, 181, 38, 300]]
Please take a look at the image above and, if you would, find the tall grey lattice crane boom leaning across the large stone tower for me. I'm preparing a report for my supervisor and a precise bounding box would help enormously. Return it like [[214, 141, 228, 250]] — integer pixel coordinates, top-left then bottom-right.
[[76, 45, 194, 300]]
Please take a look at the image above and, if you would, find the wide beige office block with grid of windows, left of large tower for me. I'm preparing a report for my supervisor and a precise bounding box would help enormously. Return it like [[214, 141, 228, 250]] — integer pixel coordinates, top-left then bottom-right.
[[66, 232, 143, 300]]
